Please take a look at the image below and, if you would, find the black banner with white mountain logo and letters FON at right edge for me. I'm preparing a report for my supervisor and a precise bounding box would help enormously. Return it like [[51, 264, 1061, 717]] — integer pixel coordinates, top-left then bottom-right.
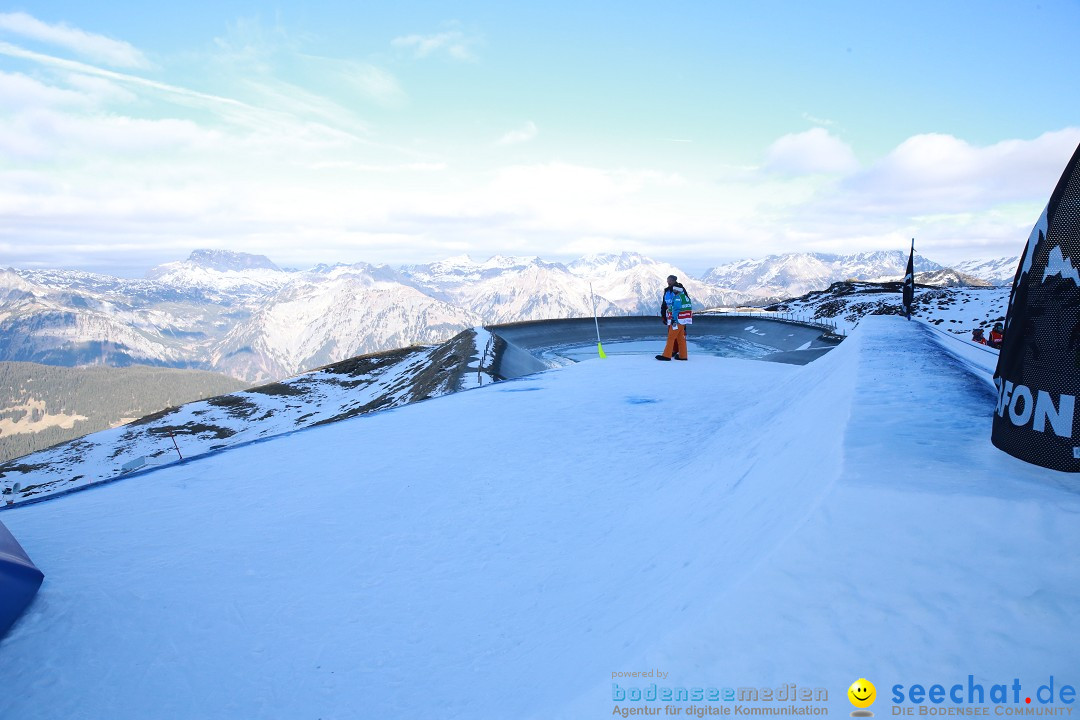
[[990, 147, 1080, 473]]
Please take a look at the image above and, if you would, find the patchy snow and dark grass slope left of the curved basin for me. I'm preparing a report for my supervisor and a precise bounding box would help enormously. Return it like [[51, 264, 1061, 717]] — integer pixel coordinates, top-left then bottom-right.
[[0, 328, 494, 502]]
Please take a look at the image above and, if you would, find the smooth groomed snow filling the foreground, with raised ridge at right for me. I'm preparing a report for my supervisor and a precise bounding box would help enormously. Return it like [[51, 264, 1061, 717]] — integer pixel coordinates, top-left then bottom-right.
[[0, 316, 1080, 720]]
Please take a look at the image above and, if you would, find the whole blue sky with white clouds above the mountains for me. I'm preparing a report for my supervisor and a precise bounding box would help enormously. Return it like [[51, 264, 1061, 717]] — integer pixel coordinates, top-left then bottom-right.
[[0, 0, 1080, 274]]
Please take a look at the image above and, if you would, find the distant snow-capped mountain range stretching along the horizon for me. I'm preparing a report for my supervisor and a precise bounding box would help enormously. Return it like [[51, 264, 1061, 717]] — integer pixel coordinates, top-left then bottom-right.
[[0, 250, 1015, 382]]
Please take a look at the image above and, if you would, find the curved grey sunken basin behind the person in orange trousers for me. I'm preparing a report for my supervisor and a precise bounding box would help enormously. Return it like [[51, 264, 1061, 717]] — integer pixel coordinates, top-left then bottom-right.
[[486, 314, 840, 379]]
